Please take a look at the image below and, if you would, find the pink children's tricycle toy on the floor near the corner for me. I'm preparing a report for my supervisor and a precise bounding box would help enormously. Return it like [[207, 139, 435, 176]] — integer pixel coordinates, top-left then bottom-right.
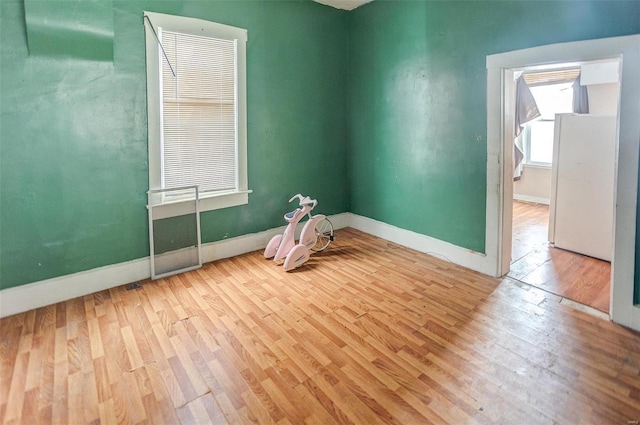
[[264, 193, 333, 271]]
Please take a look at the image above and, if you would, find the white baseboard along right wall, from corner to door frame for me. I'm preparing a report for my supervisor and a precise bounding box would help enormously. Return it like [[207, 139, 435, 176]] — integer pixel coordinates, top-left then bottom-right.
[[349, 214, 495, 276]]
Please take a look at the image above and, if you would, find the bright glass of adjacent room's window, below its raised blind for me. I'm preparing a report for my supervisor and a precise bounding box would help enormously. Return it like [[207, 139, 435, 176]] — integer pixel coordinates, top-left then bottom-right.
[[522, 82, 573, 167]]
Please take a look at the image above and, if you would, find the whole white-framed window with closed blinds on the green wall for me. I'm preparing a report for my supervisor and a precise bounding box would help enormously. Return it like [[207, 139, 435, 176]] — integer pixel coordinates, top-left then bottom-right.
[[144, 12, 250, 210]]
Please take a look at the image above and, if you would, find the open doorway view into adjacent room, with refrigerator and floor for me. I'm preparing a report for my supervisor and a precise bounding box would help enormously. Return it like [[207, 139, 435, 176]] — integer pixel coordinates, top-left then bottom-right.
[[508, 64, 619, 314]]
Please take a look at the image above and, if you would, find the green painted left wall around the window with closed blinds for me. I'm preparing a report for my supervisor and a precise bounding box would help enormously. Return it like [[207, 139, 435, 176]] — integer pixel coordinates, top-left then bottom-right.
[[0, 0, 348, 288]]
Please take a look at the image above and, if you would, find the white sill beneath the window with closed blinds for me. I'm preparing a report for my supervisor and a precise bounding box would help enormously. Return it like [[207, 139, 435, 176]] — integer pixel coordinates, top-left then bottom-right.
[[147, 190, 253, 220]]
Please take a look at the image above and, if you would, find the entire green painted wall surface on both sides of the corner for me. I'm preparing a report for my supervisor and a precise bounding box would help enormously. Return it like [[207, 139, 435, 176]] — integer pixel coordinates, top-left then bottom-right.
[[0, 0, 640, 302]]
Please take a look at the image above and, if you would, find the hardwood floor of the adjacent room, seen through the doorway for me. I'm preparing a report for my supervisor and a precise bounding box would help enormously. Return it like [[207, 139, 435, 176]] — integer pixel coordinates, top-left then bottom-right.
[[509, 201, 611, 313]]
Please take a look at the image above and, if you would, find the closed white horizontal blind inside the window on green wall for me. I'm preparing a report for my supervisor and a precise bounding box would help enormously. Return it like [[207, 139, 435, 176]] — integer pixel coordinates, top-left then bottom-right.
[[160, 31, 238, 193]]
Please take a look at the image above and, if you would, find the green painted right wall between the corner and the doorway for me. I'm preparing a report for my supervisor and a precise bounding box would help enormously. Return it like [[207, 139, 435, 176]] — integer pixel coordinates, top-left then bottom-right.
[[349, 0, 640, 252]]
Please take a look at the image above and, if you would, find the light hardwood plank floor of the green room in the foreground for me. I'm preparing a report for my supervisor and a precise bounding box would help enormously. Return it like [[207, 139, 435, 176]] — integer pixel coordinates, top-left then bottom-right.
[[0, 229, 640, 425]]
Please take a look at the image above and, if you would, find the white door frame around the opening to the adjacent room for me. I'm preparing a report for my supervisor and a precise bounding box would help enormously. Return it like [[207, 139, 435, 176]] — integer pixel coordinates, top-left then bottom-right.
[[485, 35, 640, 330]]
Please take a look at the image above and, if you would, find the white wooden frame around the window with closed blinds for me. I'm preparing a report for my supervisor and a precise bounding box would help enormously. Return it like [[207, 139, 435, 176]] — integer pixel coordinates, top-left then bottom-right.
[[143, 11, 251, 213]]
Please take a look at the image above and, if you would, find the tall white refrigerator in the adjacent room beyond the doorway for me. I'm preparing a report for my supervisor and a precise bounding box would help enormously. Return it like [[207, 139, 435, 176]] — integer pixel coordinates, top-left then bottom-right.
[[549, 114, 617, 261]]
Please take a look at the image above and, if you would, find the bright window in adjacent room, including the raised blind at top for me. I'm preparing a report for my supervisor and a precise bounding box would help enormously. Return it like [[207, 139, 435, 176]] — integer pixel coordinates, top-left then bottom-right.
[[522, 69, 580, 167]]
